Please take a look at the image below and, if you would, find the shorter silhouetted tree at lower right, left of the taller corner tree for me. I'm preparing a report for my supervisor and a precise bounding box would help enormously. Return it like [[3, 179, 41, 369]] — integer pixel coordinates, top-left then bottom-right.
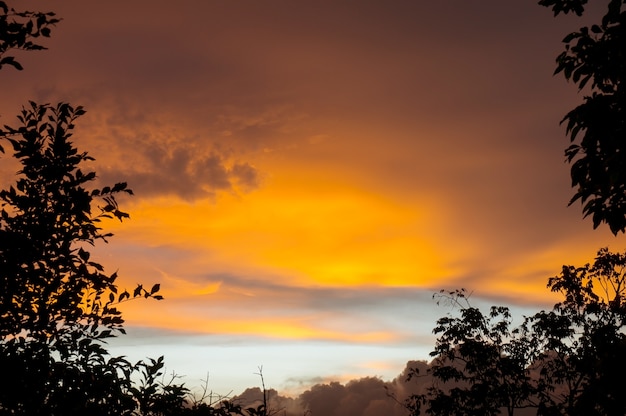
[[407, 290, 535, 416]]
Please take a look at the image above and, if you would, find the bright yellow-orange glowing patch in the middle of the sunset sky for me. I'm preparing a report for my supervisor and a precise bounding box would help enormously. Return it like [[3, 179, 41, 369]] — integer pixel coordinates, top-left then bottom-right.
[[107, 172, 452, 286]]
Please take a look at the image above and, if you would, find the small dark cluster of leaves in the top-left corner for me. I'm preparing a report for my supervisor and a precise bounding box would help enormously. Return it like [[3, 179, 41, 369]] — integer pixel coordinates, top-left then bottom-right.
[[0, 1, 60, 70]]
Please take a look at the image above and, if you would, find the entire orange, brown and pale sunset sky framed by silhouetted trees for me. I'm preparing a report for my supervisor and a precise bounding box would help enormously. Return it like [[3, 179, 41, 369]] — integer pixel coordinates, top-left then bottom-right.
[[0, 0, 625, 404]]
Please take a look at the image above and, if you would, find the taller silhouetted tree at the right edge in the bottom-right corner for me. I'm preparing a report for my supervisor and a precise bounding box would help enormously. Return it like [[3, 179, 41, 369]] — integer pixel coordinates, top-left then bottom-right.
[[527, 248, 626, 416]]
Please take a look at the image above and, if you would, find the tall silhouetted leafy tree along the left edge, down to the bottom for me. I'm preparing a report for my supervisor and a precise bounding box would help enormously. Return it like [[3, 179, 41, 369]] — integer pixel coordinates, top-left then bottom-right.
[[0, 102, 183, 415]]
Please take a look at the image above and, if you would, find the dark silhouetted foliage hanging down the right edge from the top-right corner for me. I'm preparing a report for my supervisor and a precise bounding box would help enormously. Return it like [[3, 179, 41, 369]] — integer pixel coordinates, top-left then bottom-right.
[[539, 0, 626, 234]]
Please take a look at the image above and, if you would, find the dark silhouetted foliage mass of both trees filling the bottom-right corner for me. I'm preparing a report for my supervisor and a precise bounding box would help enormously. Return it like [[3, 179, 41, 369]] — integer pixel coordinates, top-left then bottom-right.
[[406, 249, 626, 416]]
